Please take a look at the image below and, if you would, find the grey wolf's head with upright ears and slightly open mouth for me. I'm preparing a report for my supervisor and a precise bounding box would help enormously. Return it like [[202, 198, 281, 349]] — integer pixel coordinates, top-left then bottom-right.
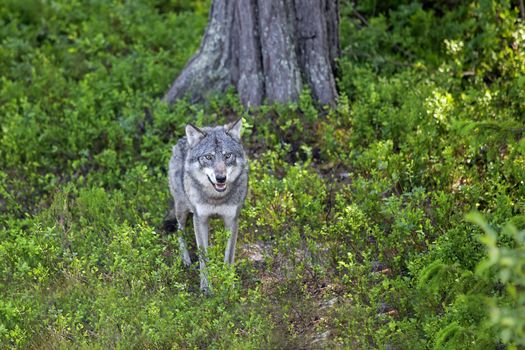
[[186, 119, 246, 197]]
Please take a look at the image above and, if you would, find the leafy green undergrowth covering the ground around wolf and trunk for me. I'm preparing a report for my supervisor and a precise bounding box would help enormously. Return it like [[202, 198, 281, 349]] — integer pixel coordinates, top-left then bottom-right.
[[0, 0, 525, 349]]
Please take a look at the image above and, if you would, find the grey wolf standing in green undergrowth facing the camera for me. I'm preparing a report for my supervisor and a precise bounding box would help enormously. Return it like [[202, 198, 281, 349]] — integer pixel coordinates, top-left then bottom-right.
[[167, 118, 249, 293]]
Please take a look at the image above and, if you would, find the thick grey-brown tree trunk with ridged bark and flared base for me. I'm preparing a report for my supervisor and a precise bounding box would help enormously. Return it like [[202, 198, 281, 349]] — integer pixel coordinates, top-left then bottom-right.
[[164, 0, 339, 106]]
